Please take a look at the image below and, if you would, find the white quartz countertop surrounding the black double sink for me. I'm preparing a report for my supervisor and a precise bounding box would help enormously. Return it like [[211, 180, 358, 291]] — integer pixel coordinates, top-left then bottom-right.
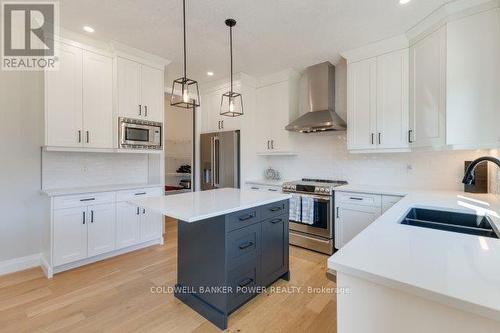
[[328, 186, 500, 321]]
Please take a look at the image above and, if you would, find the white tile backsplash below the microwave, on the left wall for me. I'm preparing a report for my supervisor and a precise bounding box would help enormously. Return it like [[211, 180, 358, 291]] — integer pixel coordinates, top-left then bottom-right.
[[42, 152, 148, 189]]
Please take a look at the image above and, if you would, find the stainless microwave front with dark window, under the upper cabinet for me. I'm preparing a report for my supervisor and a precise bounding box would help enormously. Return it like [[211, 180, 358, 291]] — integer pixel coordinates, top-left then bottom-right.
[[120, 122, 161, 147]]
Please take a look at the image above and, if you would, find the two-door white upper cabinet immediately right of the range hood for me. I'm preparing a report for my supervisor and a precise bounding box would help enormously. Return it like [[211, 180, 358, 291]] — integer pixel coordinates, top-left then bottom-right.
[[347, 49, 409, 151]]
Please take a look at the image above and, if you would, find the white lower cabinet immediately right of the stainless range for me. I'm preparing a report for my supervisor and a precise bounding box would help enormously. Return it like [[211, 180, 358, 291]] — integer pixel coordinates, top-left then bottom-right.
[[335, 192, 402, 249]]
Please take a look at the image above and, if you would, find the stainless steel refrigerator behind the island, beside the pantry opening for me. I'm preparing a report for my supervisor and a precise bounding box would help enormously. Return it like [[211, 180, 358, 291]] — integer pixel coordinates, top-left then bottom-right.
[[200, 131, 240, 191]]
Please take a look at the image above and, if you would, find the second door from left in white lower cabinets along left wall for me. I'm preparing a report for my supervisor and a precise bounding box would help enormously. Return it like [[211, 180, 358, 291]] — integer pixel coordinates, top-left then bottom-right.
[[87, 204, 116, 257]]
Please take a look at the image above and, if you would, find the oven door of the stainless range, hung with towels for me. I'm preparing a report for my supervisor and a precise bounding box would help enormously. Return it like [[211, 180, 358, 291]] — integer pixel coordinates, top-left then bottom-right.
[[290, 194, 333, 239]]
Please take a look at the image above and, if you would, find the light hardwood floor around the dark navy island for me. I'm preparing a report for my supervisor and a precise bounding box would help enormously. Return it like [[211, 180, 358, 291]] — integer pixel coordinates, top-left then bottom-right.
[[0, 220, 336, 333]]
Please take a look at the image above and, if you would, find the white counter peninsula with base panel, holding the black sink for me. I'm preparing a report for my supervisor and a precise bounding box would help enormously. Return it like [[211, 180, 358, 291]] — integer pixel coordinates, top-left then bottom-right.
[[328, 185, 500, 333]]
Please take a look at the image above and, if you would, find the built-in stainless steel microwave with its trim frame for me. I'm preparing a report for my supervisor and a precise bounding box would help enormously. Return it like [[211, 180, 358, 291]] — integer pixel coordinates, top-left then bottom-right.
[[118, 117, 163, 149]]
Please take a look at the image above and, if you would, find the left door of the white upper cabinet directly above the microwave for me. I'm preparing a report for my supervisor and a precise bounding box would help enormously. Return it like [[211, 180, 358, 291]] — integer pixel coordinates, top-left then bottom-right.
[[117, 57, 143, 119]]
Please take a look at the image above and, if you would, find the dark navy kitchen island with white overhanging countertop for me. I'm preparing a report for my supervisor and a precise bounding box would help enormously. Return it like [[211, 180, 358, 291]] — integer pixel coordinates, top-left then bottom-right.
[[132, 189, 290, 329]]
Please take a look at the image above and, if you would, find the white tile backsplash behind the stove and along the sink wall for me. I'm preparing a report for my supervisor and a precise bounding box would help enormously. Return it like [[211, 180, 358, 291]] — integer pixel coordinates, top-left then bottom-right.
[[266, 132, 494, 191]]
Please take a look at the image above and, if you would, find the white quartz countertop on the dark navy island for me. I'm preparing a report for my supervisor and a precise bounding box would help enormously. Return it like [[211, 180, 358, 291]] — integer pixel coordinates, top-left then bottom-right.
[[131, 188, 291, 222]]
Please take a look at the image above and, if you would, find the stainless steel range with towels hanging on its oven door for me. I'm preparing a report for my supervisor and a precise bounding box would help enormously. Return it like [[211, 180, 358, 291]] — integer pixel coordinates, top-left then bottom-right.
[[282, 178, 347, 254]]
